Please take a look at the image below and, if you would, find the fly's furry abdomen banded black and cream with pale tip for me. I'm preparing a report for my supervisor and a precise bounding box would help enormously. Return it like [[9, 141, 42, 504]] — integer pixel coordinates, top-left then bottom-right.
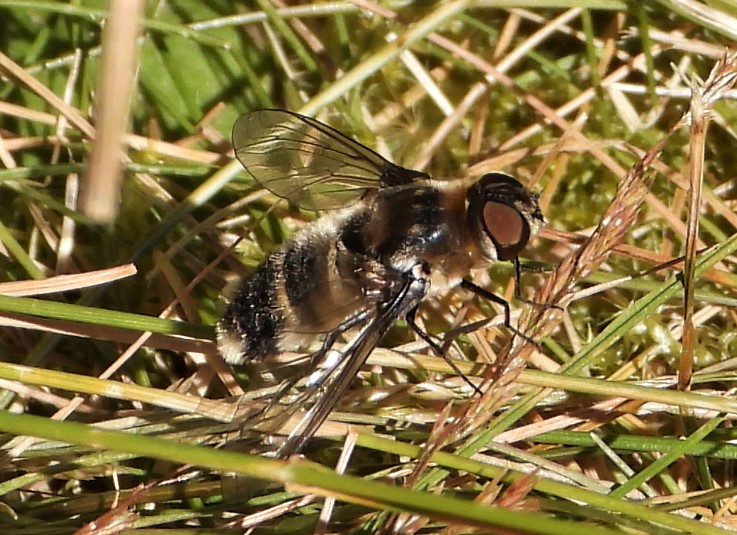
[[217, 206, 370, 364]]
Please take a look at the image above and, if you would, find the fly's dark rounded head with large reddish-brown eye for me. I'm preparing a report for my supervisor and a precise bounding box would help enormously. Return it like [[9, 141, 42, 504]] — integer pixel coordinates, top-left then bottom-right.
[[467, 173, 543, 260]]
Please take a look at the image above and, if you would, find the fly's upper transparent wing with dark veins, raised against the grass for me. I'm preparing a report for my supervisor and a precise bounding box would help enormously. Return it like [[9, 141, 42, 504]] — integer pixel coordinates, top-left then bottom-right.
[[233, 110, 428, 210]]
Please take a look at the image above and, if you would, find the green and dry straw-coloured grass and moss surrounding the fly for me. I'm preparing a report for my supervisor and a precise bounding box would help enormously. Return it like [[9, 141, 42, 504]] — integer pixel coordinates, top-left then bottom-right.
[[0, 0, 737, 535]]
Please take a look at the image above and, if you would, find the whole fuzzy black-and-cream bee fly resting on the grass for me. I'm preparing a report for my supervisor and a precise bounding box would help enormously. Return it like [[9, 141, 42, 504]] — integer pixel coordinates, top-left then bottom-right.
[[217, 110, 543, 456]]
